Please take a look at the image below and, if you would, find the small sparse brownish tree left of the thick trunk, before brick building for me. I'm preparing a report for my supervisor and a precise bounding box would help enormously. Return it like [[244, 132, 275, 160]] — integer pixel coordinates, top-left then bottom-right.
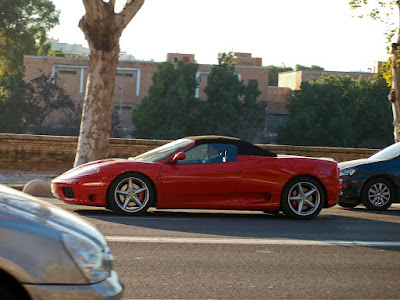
[[26, 74, 75, 134]]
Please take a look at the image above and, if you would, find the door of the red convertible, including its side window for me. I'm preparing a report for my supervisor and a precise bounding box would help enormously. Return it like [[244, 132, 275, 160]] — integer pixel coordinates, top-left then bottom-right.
[[158, 144, 242, 209]]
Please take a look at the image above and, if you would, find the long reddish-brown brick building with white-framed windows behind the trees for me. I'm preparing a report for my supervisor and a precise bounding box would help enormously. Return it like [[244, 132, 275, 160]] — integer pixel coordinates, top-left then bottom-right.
[[24, 53, 268, 135]]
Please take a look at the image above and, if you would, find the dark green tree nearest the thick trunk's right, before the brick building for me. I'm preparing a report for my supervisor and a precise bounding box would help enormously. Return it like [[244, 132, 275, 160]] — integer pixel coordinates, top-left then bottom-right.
[[133, 61, 198, 139]]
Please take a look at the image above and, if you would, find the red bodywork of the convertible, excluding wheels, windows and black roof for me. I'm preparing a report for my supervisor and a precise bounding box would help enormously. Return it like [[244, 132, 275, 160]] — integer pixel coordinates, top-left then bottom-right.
[[52, 137, 341, 211]]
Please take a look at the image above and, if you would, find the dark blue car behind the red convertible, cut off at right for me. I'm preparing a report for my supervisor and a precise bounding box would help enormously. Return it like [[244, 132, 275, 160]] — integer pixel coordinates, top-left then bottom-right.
[[339, 143, 400, 210]]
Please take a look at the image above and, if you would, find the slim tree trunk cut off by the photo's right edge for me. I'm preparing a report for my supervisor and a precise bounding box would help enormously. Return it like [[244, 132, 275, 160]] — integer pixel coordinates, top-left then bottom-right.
[[389, 1, 400, 142]]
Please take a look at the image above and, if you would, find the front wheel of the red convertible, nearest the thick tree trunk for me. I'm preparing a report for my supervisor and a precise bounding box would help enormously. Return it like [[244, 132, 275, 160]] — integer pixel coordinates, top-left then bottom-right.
[[107, 173, 155, 215]]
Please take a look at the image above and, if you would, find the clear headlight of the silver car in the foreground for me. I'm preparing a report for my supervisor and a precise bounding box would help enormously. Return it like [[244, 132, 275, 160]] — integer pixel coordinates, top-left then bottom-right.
[[62, 233, 112, 283]]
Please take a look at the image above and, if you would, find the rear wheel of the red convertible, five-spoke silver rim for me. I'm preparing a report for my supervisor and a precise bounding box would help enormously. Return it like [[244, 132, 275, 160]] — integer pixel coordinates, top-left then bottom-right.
[[281, 176, 325, 220]]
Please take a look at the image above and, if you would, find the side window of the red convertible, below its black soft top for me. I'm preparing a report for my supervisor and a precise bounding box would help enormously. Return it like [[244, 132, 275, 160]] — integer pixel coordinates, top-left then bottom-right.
[[177, 143, 237, 165]]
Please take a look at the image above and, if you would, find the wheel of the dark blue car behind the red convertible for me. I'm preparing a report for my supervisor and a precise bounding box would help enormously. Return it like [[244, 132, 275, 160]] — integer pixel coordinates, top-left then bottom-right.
[[361, 177, 395, 211]]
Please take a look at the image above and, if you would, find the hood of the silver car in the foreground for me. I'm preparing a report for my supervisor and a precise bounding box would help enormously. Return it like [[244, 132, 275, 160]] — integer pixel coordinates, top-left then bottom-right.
[[0, 185, 106, 247]]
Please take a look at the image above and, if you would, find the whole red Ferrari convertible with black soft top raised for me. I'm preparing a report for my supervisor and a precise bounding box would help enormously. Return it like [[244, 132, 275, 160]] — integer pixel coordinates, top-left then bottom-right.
[[51, 136, 341, 219]]
